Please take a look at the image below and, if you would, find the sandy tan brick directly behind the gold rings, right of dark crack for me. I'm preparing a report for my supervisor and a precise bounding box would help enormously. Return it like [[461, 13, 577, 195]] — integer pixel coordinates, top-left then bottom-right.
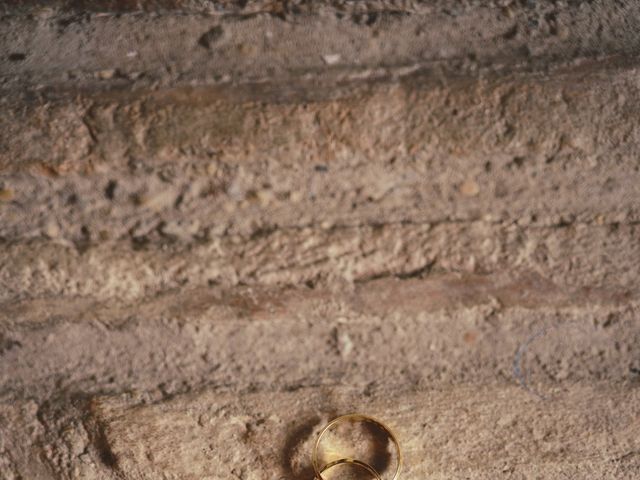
[[85, 384, 640, 480]]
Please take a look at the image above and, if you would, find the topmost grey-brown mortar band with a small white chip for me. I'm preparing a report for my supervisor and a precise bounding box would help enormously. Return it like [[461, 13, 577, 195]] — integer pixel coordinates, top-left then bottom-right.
[[0, 0, 638, 93]]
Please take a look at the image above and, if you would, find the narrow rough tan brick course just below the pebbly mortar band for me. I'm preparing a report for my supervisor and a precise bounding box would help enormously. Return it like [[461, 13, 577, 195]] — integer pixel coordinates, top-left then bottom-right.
[[0, 218, 640, 301]]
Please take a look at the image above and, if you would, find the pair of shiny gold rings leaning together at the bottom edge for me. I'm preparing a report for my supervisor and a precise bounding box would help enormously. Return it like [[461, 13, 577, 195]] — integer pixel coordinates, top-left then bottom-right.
[[311, 413, 402, 480]]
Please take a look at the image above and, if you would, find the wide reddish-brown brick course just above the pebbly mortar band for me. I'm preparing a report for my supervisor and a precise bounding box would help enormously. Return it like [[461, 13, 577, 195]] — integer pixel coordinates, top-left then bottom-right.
[[0, 59, 638, 172]]
